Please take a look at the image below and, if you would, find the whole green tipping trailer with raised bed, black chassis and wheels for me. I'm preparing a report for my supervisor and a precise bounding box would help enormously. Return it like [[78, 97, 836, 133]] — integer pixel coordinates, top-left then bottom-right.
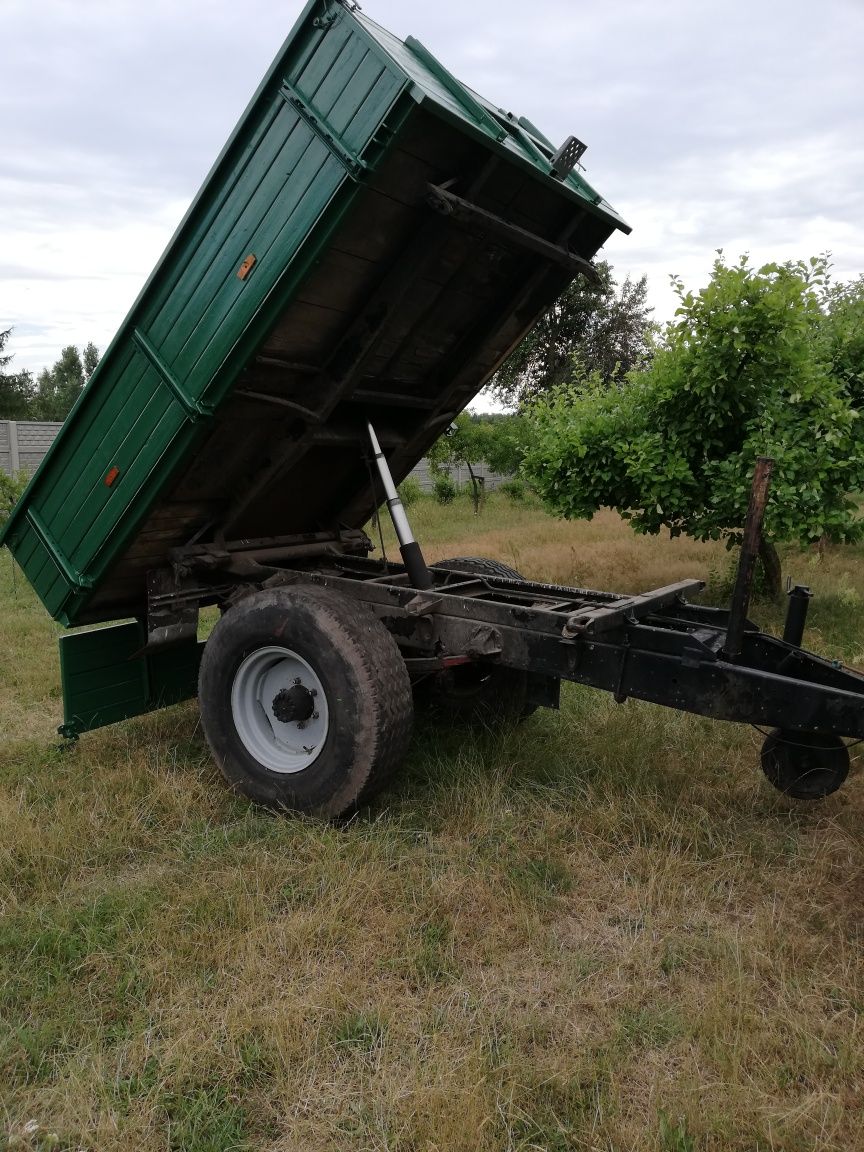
[[3, 0, 864, 818]]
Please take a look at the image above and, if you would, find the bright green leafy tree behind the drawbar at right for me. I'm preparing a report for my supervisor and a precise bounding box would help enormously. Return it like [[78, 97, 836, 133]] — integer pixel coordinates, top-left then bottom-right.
[[524, 253, 864, 593]]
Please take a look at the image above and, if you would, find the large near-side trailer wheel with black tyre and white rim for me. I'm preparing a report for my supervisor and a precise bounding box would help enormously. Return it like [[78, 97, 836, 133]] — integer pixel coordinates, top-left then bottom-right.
[[198, 584, 414, 819]]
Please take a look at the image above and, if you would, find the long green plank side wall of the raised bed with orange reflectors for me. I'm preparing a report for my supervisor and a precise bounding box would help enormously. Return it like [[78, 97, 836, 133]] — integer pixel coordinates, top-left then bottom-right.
[[0, 0, 410, 623]]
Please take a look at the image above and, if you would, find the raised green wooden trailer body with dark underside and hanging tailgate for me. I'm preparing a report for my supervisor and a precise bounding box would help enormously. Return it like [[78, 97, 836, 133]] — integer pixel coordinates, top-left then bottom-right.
[[2, 0, 629, 728]]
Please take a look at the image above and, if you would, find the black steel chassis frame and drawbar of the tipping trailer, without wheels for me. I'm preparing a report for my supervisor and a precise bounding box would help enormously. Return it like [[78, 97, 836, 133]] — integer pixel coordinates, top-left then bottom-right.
[[274, 560, 864, 738]]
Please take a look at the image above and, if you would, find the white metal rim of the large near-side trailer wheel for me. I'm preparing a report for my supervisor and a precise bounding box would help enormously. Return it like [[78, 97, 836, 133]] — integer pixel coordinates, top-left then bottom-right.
[[232, 645, 329, 773]]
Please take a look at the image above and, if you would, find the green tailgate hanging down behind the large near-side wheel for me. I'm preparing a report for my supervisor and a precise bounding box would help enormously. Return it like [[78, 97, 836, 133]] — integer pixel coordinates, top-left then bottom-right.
[[60, 621, 204, 736]]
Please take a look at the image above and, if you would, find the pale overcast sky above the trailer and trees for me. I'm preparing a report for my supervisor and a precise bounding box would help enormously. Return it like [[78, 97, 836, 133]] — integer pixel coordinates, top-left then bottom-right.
[[0, 0, 864, 387]]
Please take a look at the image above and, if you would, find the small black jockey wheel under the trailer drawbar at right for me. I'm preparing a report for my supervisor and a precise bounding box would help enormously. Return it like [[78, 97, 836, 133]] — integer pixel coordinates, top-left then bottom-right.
[[761, 728, 849, 799]]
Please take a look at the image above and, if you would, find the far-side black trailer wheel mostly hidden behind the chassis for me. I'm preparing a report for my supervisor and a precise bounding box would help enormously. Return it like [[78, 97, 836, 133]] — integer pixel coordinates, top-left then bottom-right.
[[415, 556, 537, 726]]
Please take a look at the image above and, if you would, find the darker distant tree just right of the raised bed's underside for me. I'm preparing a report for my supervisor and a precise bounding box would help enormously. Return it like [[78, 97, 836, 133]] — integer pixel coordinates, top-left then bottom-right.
[[492, 260, 655, 406]]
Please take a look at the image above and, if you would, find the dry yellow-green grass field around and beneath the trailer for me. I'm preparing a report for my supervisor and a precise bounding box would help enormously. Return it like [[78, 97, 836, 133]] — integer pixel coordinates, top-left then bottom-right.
[[0, 497, 864, 1152]]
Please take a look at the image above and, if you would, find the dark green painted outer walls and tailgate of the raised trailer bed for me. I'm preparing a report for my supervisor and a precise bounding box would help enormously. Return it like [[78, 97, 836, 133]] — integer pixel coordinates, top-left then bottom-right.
[[0, 0, 629, 733]]
